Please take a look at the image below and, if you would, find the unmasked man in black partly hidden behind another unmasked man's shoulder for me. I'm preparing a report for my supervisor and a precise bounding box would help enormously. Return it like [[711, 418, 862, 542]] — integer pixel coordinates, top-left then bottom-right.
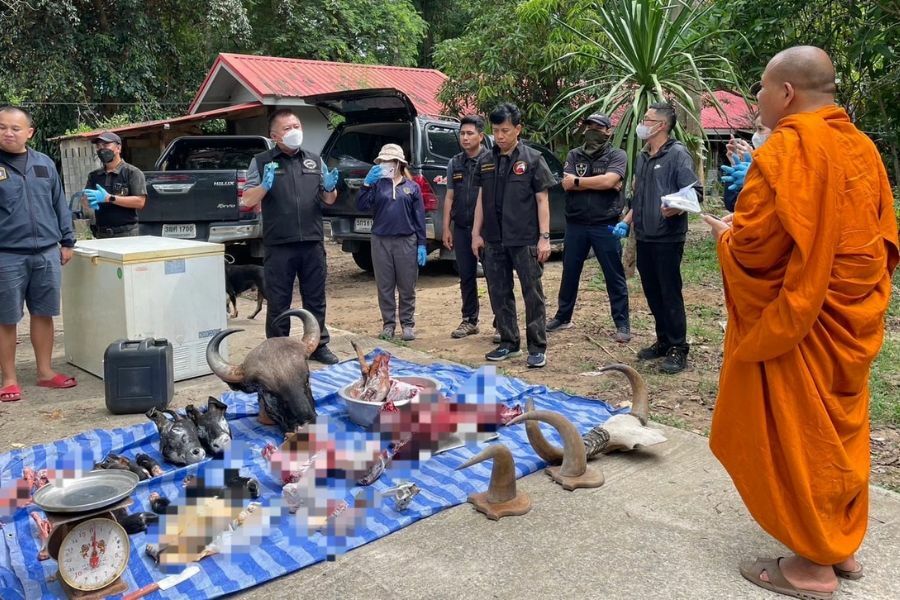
[[444, 115, 490, 338]]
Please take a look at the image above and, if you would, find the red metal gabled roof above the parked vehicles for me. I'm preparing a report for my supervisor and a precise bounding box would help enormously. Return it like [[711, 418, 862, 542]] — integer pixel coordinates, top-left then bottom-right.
[[189, 53, 447, 115]]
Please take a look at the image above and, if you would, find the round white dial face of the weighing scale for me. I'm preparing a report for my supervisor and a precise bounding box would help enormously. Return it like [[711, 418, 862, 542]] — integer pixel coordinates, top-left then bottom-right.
[[57, 517, 131, 592]]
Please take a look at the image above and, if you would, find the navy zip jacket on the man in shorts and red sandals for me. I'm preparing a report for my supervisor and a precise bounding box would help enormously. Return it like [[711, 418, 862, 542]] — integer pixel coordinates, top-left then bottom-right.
[[0, 148, 75, 254]]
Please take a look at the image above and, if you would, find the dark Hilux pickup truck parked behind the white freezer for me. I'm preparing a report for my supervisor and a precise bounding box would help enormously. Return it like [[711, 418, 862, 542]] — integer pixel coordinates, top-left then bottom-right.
[[138, 135, 273, 262]]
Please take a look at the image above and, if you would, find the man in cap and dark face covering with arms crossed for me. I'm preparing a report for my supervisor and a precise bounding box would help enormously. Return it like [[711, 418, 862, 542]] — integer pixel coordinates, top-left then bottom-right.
[[547, 113, 631, 343]]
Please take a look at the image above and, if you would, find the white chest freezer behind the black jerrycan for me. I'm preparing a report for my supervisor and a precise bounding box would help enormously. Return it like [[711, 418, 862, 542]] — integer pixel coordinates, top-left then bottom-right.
[[62, 236, 227, 381]]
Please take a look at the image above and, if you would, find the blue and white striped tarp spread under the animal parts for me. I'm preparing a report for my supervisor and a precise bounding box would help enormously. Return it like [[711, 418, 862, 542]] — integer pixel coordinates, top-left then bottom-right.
[[0, 358, 617, 600]]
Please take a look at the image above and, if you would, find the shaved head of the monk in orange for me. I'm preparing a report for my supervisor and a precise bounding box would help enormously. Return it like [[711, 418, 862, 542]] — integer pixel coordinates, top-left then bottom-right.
[[757, 46, 837, 129]]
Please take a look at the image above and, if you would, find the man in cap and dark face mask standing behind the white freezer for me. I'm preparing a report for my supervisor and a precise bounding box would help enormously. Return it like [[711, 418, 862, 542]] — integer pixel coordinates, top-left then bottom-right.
[[82, 131, 147, 238]]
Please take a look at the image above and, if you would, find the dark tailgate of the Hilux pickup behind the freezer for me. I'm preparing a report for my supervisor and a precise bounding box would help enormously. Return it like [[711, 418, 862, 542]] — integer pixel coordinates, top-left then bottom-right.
[[140, 169, 240, 223]]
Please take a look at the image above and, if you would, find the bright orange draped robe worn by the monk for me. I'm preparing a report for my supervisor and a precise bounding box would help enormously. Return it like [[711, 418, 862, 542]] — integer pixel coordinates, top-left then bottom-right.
[[709, 106, 898, 564]]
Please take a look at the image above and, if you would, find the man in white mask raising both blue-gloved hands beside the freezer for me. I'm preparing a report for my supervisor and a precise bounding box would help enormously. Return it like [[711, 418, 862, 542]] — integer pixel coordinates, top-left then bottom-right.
[[241, 109, 338, 365]]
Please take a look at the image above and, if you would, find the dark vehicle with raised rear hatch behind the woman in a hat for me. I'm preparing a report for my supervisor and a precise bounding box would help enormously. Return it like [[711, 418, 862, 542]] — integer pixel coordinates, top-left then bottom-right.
[[306, 89, 566, 271]]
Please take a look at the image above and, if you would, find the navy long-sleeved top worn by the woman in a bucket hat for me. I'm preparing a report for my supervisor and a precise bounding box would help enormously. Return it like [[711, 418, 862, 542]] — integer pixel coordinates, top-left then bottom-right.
[[356, 177, 425, 246]]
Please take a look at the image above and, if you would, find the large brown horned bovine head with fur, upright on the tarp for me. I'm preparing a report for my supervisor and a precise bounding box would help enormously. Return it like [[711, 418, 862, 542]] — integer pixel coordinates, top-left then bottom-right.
[[206, 309, 320, 432]]
